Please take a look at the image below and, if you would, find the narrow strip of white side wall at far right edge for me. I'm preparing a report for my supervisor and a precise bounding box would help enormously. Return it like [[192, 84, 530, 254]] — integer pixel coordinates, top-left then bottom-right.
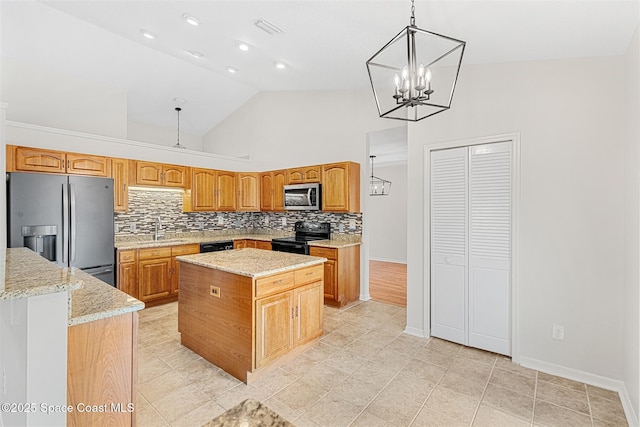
[[623, 25, 640, 424]]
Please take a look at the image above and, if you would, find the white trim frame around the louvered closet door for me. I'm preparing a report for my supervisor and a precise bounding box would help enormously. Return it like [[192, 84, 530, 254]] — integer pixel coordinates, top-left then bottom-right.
[[422, 132, 521, 364]]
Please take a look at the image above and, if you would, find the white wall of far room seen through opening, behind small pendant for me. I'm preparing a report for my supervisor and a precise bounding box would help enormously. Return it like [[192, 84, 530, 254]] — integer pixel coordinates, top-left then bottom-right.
[[366, 160, 407, 263]]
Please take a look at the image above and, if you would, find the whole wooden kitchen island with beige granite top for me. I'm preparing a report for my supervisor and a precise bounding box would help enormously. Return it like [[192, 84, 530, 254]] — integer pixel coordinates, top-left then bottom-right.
[[177, 248, 326, 383]]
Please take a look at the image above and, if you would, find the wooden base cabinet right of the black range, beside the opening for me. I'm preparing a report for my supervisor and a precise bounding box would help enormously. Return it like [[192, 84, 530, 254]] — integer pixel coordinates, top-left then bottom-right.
[[309, 245, 360, 307]]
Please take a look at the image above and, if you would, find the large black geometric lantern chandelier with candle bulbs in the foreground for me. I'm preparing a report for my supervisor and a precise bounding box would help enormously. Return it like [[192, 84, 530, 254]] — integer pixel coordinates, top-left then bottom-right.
[[367, 0, 466, 122]]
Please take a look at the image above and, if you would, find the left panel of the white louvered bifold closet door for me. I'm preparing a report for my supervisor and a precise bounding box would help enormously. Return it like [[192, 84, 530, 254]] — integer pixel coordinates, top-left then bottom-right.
[[431, 147, 468, 344]]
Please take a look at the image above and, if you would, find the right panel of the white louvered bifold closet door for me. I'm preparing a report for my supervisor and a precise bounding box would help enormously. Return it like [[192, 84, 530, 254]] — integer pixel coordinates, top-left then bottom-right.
[[469, 143, 511, 355]]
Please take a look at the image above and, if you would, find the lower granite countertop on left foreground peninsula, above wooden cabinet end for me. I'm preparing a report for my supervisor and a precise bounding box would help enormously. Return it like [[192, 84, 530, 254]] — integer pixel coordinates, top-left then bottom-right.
[[69, 269, 144, 326]]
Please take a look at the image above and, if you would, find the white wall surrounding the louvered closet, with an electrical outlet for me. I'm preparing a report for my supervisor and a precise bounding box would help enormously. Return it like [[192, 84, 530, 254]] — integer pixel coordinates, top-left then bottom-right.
[[407, 57, 626, 382]]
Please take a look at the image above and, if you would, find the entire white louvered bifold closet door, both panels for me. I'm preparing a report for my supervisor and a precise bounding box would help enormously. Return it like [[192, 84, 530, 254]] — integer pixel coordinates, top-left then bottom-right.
[[431, 143, 511, 355]]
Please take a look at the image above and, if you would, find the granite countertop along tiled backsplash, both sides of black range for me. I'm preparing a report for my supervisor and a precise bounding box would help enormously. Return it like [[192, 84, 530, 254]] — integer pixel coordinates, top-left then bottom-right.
[[115, 232, 362, 250]]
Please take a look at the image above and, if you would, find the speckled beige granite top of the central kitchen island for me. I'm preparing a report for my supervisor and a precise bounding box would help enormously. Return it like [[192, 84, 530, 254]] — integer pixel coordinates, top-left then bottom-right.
[[176, 248, 327, 278]]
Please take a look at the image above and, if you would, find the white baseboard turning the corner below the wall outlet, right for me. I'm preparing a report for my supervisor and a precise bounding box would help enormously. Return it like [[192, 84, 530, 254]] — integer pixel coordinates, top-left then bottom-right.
[[520, 356, 640, 427]]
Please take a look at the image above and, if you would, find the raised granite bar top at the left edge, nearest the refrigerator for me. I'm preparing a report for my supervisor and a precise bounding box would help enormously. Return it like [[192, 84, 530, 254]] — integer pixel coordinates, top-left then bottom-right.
[[0, 248, 83, 300]]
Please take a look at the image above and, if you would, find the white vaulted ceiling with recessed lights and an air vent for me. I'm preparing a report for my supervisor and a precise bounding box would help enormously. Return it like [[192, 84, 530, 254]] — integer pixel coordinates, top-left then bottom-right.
[[1, 0, 639, 149]]
